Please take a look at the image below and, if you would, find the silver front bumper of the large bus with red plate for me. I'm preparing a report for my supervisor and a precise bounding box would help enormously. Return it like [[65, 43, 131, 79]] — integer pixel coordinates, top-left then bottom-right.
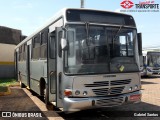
[[63, 91, 141, 111]]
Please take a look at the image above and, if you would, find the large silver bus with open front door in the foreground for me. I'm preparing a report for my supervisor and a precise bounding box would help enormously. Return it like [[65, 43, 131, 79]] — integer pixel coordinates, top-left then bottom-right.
[[15, 8, 142, 111]]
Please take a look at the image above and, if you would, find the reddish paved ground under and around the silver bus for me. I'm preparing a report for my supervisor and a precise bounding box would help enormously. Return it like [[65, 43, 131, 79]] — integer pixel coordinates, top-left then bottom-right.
[[0, 75, 160, 120]]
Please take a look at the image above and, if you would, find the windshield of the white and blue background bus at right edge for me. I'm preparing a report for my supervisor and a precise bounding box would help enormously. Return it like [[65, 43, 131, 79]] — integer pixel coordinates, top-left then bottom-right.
[[148, 52, 160, 67]]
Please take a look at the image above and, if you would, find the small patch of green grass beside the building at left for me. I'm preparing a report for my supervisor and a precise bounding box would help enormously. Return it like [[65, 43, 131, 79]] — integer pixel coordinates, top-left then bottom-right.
[[0, 79, 19, 86]]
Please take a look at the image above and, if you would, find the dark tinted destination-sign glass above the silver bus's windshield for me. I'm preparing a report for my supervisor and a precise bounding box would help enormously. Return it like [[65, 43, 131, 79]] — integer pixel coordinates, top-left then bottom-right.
[[66, 9, 135, 26]]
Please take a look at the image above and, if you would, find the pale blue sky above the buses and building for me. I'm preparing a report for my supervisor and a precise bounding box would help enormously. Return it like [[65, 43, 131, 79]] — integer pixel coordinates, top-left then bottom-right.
[[0, 0, 160, 47]]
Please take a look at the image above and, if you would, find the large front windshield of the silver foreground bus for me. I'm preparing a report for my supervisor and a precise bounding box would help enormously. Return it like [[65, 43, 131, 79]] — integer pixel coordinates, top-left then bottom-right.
[[64, 24, 138, 74]]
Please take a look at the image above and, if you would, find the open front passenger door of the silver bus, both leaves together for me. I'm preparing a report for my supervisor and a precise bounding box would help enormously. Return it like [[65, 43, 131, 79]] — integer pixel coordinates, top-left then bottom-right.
[[46, 28, 62, 107]]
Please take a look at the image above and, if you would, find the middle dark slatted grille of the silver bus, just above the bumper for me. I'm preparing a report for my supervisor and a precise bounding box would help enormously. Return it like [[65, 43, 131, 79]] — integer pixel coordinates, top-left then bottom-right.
[[92, 86, 124, 96]]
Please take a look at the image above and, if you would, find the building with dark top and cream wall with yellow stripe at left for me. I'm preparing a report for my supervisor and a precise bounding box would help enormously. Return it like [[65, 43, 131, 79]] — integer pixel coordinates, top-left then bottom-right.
[[0, 26, 24, 78]]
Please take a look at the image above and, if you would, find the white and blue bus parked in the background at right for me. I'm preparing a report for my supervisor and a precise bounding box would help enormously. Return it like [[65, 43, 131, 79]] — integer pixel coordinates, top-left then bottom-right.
[[141, 50, 160, 76]]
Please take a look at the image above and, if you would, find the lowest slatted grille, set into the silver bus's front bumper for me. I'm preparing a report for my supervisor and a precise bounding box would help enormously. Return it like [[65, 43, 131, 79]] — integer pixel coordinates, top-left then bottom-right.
[[96, 97, 123, 107]]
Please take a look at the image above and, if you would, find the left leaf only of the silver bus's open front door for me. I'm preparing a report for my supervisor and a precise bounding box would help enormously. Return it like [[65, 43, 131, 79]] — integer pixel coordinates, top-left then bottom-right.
[[45, 31, 57, 103]]
